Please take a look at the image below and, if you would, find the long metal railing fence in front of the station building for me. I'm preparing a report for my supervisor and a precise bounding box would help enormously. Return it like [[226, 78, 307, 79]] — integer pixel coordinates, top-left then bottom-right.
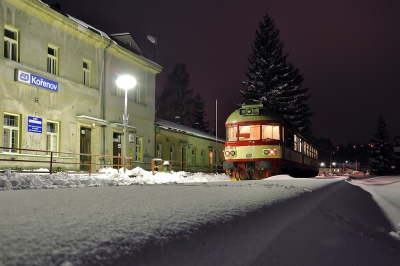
[[0, 147, 223, 175]]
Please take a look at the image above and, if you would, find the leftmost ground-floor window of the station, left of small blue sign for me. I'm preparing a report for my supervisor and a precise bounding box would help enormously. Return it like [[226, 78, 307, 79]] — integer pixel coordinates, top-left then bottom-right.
[[3, 113, 20, 153]]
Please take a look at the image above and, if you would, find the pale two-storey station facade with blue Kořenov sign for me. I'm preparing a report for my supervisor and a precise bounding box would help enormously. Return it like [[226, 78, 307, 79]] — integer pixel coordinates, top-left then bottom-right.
[[0, 0, 162, 170]]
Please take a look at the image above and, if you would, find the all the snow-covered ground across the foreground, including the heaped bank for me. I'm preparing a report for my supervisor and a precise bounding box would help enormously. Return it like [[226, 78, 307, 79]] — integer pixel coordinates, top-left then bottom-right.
[[0, 168, 400, 266]]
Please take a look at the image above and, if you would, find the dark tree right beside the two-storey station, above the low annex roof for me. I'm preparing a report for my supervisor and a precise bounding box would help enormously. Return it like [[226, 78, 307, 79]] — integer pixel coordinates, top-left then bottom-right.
[[157, 63, 194, 126]]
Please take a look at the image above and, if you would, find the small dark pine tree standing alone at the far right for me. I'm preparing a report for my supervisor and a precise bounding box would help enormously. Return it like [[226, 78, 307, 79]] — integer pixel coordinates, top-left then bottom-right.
[[370, 115, 394, 175]]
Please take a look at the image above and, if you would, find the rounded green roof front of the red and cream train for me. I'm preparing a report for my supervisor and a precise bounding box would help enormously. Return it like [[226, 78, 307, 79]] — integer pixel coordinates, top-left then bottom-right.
[[226, 103, 286, 124]]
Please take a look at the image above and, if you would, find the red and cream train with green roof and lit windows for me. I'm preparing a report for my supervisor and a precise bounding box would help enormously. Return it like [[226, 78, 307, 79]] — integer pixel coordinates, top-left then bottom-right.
[[223, 101, 319, 180]]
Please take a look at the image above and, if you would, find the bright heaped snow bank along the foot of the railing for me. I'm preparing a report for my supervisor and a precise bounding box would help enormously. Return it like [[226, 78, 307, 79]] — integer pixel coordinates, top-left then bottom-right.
[[0, 167, 230, 190]]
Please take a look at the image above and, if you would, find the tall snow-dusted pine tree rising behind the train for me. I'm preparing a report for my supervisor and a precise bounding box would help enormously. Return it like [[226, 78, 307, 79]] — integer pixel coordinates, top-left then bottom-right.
[[240, 15, 312, 136]]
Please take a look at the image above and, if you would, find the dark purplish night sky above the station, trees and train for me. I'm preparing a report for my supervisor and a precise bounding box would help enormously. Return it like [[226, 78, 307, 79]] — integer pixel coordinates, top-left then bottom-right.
[[52, 0, 400, 144]]
